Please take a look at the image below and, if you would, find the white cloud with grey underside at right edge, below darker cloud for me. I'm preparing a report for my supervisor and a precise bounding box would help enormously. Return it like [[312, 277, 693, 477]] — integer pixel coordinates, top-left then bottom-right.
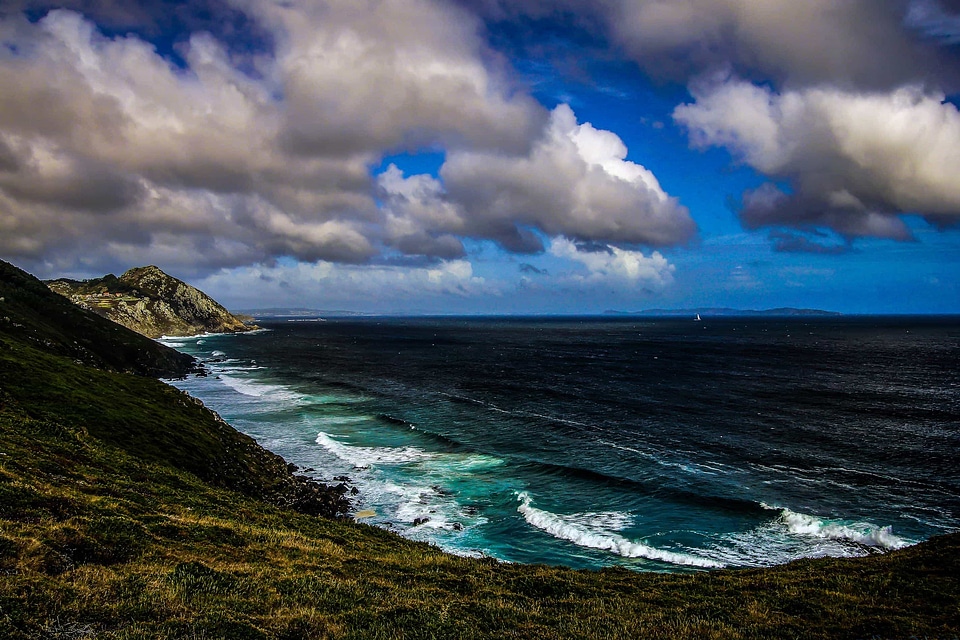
[[674, 78, 960, 240]]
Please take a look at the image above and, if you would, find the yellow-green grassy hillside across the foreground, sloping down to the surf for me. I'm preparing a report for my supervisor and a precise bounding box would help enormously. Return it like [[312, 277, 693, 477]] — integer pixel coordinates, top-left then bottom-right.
[[0, 262, 960, 639]]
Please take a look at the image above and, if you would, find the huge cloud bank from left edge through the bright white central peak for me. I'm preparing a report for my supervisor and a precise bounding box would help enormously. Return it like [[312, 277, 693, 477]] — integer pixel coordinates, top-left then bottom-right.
[[0, 0, 695, 274]]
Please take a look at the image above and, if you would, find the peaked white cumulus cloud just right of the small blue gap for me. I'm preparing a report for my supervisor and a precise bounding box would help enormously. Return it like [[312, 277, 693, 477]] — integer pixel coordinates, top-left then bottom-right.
[[440, 105, 695, 252]]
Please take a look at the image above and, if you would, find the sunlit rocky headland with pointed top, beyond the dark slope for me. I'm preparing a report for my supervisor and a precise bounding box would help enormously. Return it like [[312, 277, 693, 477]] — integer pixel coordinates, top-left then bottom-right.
[[47, 266, 256, 338]]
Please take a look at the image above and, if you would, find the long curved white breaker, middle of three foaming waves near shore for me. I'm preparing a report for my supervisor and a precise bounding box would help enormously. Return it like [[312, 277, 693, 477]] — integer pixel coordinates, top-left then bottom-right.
[[517, 492, 723, 568]]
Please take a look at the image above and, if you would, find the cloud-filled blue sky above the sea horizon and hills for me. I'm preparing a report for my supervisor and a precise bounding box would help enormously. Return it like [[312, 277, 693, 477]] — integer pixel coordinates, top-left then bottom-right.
[[0, 0, 960, 314]]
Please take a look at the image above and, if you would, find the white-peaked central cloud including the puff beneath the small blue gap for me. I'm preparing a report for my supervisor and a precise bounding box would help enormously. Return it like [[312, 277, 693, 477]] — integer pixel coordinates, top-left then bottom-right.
[[377, 105, 695, 258]]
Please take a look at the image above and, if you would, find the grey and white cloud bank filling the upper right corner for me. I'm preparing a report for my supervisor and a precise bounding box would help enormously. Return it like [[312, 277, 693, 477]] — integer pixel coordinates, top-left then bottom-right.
[[467, 0, 960, 248]]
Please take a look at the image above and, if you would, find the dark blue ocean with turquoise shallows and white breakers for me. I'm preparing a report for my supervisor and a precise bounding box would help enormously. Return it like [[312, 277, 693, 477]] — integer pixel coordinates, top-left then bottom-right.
[[163, 317, 960, 572]]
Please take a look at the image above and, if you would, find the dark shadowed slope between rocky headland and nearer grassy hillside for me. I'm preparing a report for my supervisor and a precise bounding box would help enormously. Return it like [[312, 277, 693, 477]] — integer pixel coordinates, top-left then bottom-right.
[[0, 260, 196, 378]]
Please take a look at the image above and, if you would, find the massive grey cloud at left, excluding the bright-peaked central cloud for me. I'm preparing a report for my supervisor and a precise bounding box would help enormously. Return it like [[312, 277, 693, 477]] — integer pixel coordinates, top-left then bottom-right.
[[0, 0, 546, 276]]
